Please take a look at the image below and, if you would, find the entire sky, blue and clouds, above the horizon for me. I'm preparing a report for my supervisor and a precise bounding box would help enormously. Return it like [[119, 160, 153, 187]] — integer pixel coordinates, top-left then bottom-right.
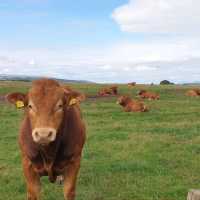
[[0, 0, 200, 83]]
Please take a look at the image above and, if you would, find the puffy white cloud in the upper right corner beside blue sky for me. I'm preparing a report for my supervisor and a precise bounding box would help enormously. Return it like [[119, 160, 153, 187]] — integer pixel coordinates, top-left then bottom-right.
[[112, 0, 200, 34]]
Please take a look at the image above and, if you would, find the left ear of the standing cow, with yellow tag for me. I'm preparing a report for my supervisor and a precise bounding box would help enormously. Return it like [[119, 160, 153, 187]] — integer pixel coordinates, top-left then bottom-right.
[[6, 92, 27, 108]]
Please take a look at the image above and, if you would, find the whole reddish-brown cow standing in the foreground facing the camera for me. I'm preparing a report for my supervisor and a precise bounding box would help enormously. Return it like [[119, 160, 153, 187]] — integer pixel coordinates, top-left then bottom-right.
[[7, 79, 85, 200]]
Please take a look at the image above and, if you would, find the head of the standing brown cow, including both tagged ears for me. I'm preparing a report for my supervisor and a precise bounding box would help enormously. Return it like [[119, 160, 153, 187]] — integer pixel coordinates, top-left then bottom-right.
[[7, 79, 83, 145]]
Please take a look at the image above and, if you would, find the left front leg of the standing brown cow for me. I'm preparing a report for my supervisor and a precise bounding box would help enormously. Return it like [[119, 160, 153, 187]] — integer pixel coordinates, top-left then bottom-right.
[[23, 158, 41, 200]]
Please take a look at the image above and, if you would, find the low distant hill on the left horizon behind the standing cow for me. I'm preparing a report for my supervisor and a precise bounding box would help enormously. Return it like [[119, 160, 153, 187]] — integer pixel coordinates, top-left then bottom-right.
[[0, 74, 92, 83]]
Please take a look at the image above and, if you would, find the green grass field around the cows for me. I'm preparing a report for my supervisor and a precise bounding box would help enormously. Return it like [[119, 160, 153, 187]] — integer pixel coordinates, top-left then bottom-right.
[[0, 82, 200, 200]]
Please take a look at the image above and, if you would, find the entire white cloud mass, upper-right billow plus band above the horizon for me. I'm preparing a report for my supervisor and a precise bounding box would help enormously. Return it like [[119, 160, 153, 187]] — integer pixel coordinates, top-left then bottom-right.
[[0, 0, 200, 83]]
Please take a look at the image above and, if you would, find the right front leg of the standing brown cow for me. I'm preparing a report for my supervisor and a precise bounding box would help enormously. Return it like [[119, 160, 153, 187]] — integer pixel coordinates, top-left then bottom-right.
[[64, 158, 80, 200]]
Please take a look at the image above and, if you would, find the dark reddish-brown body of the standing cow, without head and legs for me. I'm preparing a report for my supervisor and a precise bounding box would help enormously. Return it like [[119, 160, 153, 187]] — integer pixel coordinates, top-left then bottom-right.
[[19, 107, 85, 182]]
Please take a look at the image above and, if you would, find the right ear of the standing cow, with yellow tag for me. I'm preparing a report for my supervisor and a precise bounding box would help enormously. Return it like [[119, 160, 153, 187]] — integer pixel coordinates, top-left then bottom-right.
[[65, 90, 86, 106]]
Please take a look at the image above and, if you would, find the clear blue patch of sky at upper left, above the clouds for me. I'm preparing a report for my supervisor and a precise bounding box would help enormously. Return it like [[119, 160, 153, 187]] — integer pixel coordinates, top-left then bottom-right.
[[0, 0, 125, 47]]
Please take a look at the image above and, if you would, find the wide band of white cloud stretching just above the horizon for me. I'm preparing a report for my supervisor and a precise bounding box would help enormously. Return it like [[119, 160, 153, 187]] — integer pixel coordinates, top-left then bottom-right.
[[0, 38, 200, 83]]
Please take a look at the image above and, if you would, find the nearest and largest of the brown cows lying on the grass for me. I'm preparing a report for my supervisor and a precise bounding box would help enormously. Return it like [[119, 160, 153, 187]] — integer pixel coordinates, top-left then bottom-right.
[[117, 96, 149, 112]]
